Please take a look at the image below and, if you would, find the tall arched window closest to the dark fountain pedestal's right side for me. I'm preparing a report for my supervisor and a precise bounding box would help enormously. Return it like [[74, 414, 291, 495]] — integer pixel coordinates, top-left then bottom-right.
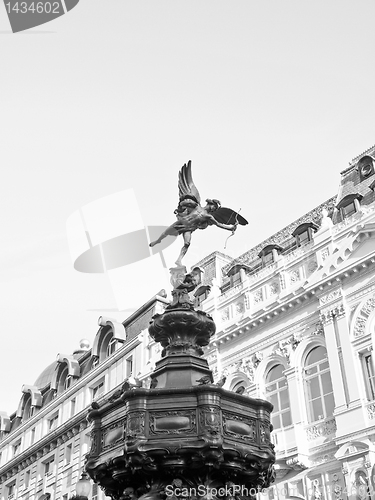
[[266, 365, 292, 429]]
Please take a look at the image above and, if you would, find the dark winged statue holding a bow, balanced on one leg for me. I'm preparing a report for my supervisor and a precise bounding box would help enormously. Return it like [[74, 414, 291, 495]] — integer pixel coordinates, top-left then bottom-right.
[[150, 161, 248, 266]]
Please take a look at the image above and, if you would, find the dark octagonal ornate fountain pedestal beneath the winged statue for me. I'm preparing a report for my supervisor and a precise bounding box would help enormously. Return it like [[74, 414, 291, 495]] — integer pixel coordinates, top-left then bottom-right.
[[86, 300, 275, 500]]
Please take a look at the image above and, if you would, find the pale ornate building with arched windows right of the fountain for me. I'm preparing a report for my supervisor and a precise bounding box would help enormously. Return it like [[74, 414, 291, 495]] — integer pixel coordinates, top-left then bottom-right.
[[196, 147, 375, 499]]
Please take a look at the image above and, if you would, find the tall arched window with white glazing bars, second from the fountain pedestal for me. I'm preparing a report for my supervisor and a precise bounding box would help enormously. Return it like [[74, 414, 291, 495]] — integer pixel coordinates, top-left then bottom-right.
[[304, 346, 335, 422]]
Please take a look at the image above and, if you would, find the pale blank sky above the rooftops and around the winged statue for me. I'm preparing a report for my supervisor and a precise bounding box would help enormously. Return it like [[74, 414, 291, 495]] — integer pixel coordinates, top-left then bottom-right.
[[0, 0, 375, 413]]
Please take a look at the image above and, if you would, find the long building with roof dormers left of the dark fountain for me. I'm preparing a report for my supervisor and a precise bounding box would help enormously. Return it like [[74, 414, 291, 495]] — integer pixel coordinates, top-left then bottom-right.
[[0, 293, 167, 500]]
